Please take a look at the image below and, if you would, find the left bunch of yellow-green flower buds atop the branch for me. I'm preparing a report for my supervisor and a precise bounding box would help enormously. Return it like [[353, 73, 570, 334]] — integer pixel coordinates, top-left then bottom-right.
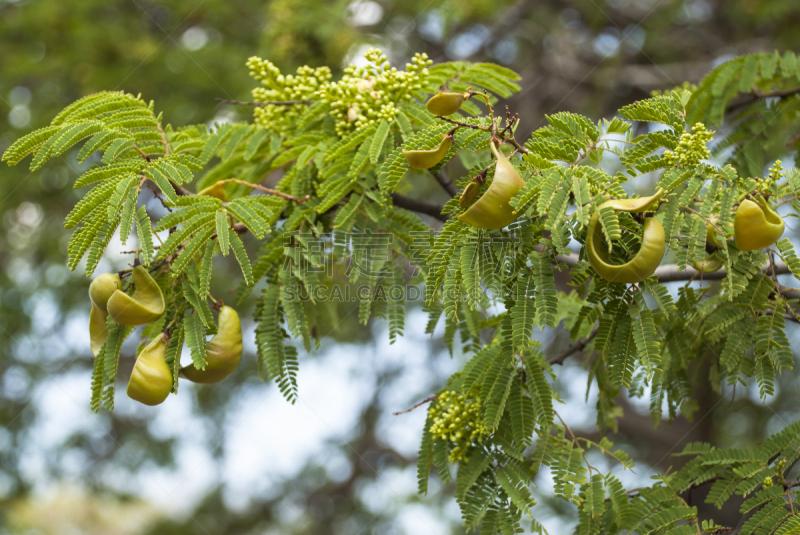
[[247, 56, 332, 131]]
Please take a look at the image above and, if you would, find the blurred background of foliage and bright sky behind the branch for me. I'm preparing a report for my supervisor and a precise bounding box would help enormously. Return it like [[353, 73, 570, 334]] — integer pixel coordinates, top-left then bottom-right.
[[0, 0, 800, 535]]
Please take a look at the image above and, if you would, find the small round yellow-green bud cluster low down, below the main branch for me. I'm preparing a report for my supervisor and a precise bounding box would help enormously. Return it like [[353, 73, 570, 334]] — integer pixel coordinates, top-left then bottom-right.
[[430, 390, 489, 463]]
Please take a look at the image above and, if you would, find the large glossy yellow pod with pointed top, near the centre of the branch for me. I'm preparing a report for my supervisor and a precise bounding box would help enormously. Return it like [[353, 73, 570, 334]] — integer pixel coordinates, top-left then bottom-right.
[[458, 143, 525, 229]]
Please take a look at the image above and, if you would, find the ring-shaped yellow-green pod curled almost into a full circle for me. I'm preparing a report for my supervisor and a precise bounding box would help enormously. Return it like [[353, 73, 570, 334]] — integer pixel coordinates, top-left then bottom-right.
[[586, 189, 666, 284]]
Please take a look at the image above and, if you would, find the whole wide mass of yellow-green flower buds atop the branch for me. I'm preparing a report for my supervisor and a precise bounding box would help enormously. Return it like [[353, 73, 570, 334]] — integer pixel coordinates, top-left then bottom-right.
[[247, 49, 433, 137]]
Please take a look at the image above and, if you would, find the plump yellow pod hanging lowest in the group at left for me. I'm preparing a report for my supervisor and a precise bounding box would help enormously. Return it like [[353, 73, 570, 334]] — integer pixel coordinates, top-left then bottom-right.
[[127, 335, 172, 405]]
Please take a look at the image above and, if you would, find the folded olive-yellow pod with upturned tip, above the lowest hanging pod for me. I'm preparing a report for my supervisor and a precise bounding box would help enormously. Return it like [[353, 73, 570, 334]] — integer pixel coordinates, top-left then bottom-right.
[[108, 266, 164, 325]]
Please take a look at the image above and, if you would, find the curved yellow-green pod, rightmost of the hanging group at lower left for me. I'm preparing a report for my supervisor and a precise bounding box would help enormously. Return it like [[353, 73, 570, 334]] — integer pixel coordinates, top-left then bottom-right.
[[181, 306, 242, 384]]
